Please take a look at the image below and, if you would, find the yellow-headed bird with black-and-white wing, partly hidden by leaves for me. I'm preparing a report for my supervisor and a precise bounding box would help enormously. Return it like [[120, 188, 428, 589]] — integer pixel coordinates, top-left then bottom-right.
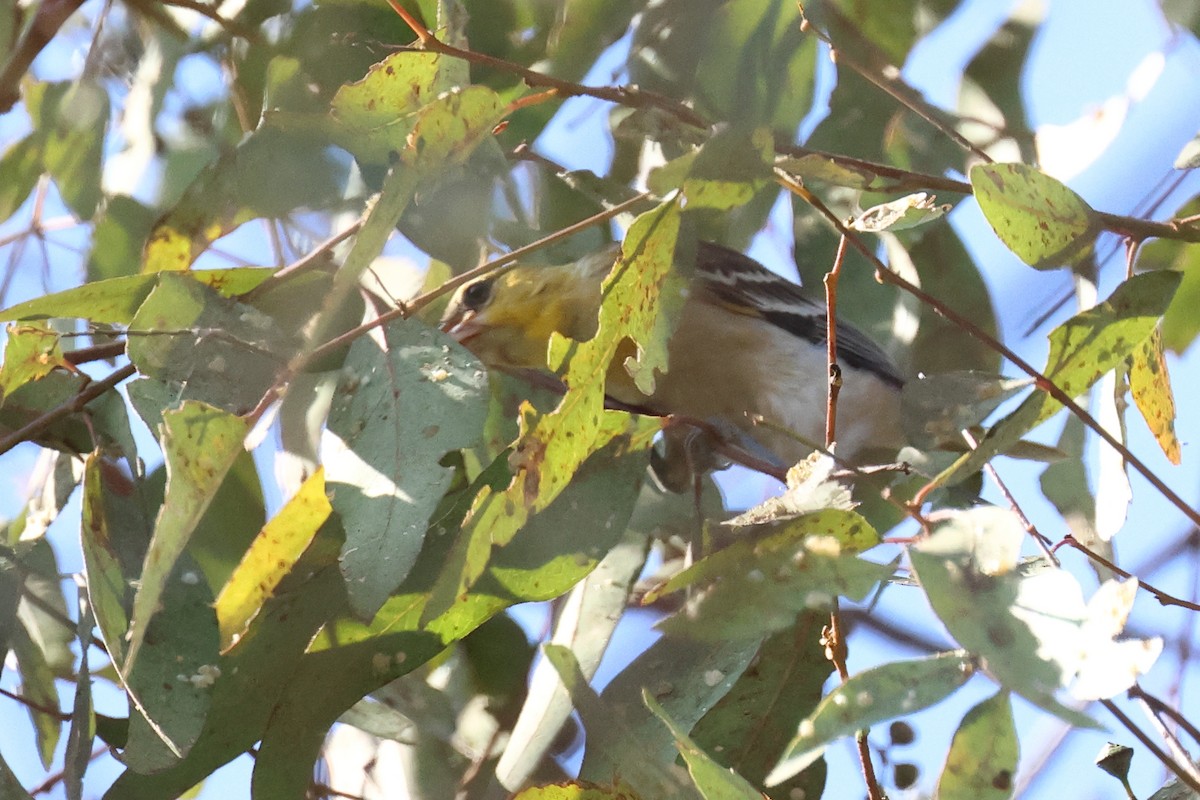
[[442, 241, 905, 467]]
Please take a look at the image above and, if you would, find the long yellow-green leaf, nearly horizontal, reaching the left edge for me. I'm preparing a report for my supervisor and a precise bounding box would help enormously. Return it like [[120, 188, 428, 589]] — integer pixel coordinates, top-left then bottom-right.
[[0, 267, 275, 325]]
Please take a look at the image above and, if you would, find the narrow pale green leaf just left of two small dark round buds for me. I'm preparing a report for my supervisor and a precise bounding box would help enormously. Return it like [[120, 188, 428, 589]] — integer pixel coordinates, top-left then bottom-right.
[[767, 650, 976, 786]]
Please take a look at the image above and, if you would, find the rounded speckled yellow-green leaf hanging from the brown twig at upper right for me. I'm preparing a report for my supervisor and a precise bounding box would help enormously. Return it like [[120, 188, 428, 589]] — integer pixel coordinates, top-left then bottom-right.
[[971, 164, 1099, 270]]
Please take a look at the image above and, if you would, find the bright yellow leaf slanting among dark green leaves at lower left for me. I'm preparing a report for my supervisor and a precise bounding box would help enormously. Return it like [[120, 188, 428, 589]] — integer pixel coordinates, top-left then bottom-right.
[[216, 469, 332, 650]]
